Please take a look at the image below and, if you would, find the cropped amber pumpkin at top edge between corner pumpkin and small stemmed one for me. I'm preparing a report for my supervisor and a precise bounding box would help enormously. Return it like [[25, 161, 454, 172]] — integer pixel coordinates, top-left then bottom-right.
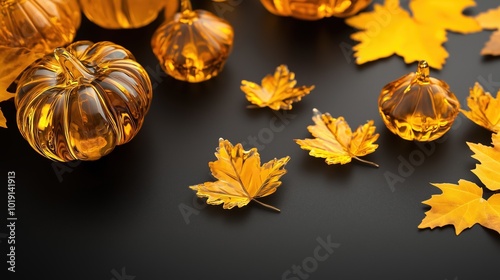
[[80, 0, 179, 29]]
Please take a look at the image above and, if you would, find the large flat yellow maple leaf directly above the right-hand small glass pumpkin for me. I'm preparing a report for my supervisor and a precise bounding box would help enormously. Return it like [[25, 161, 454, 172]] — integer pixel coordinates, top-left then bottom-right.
[[346, 0, 448, 69]]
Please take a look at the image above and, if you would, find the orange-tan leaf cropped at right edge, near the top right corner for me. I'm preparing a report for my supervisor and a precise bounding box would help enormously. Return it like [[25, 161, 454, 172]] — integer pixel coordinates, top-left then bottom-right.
[[476, 6, 500, 55]]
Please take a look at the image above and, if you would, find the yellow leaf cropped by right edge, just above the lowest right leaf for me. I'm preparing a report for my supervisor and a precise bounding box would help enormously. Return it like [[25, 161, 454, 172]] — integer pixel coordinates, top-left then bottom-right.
[[467, 133, 500, 191]]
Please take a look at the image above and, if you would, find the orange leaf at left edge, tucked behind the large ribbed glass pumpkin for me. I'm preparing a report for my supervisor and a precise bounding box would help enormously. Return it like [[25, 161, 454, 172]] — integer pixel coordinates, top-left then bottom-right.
[[0, 46, 42, 127]]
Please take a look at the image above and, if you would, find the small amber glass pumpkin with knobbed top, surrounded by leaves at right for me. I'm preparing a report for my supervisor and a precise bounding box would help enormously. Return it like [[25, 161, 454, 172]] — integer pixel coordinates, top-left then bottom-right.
[[378, 61, 460, 141]]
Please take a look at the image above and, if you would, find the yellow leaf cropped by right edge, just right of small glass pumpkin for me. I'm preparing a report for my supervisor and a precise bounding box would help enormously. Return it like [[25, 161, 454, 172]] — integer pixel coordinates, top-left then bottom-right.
[[460, 82, 500, 132]]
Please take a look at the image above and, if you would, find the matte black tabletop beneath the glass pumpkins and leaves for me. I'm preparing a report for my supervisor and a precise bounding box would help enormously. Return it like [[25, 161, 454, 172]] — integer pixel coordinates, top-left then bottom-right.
[[0, 0, 500, 280]]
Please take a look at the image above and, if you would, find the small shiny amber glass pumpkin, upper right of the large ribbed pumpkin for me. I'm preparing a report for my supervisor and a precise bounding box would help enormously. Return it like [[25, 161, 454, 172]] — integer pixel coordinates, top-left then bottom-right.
[[151, 0, 234, 83]]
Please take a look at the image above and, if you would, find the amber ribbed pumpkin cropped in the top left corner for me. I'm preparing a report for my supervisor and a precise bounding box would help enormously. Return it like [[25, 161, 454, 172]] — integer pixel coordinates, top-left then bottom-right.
[[0, 0, 81, 54]]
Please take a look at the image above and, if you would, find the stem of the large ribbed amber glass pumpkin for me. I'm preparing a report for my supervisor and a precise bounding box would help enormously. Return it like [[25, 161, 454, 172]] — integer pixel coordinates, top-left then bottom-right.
[[54, 48, 94, 82]]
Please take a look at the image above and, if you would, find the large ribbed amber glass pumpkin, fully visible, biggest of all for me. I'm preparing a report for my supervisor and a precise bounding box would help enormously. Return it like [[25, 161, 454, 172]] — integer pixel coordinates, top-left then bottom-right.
[[15, 41, 152, 161]]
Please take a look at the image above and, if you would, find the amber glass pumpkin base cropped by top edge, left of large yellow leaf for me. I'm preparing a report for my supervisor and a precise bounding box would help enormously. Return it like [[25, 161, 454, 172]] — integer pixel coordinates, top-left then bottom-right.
[[260, 0, 371, 20]]
